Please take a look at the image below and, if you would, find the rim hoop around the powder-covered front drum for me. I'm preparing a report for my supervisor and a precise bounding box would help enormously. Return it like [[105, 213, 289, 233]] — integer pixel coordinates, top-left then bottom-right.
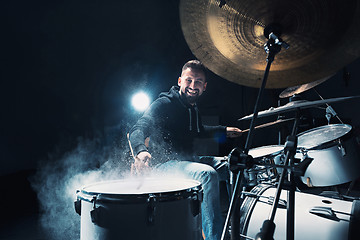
[[77, 178, 202, 202]]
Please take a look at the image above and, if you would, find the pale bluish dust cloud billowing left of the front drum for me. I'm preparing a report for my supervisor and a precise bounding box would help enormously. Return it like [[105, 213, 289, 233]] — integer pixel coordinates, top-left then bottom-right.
[[32, 134, 130, 240]]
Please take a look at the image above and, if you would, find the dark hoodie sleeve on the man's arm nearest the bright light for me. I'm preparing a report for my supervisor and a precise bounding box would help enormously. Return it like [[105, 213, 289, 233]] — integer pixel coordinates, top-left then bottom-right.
[[129, 99, 163, 156]]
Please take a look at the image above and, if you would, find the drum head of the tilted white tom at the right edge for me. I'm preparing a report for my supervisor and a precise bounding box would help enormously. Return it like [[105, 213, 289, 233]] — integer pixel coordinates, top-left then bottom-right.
[[298, 124, 352, 149]]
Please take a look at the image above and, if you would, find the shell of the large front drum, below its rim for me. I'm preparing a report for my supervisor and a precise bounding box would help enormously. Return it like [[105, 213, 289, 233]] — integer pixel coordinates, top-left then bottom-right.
[[80, 180, 202, 240]]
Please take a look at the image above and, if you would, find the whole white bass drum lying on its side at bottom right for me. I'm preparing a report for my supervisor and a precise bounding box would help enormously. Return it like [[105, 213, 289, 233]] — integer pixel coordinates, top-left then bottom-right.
[[240, 184, 360, 240]]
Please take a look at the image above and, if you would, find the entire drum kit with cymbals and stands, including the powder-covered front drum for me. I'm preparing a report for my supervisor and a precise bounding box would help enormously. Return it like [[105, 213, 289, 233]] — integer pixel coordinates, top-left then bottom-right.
[[75, 0, 360, 240]]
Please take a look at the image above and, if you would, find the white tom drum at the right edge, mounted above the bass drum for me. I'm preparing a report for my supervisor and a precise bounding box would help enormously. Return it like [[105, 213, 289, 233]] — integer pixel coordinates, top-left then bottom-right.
[[297, 124, 360, 187]]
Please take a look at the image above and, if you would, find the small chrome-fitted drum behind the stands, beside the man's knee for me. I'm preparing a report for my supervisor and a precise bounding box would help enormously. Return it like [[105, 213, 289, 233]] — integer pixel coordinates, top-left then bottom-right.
[[247, 145, 284, 183]]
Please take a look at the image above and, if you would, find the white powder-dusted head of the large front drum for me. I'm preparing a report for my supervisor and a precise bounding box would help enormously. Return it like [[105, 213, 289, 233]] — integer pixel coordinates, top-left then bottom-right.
[[82, 178, 200, 195]]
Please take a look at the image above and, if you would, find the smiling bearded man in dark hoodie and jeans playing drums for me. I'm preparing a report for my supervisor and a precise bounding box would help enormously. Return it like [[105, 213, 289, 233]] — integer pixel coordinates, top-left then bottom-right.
[[129, 60, 242, 240]]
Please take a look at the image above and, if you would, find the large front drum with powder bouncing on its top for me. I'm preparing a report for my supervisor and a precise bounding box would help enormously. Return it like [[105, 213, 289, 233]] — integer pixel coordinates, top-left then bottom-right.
[[75, 178, 202, 240]]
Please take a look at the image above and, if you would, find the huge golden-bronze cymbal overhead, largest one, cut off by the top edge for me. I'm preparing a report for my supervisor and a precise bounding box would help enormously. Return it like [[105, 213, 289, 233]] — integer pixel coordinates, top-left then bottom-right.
[[179, 0, 360, 88]]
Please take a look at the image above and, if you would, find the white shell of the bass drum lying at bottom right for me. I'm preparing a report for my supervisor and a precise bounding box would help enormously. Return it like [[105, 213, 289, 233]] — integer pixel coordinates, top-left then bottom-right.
[[241, 185, 352, 240]]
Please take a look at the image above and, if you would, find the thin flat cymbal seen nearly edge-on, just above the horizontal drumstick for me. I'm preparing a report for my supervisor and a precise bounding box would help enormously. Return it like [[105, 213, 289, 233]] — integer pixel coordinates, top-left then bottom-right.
[[238, 96, 360, 121]]
